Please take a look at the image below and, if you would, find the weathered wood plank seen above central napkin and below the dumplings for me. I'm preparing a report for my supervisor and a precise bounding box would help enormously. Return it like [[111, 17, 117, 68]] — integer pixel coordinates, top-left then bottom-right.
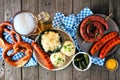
[[56, 0, 73, 80]]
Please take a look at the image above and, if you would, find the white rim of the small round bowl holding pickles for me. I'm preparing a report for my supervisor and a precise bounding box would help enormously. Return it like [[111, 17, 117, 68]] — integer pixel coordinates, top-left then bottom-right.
[[72, 52, 92, 71]]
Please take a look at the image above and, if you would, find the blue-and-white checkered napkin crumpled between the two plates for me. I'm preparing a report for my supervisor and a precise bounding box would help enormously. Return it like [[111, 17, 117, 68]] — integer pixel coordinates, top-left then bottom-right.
[[52, 7, 105, 66]]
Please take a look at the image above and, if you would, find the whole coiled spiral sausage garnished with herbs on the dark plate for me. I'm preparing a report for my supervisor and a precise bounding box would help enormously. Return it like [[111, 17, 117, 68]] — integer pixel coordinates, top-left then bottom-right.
[[80, 15, 109, 42]]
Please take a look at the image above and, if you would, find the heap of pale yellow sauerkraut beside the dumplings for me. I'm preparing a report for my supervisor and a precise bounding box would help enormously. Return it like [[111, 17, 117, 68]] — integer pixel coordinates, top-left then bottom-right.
[[41, 31, 61, 52]]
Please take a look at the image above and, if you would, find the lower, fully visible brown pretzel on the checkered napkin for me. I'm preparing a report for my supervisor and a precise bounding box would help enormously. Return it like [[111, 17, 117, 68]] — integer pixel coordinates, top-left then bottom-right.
[[3, 42, 32, 67]]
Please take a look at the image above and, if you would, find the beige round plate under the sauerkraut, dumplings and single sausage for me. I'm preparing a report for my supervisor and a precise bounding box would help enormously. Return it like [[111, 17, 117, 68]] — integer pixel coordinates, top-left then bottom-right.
[[34, 28, 74, 71]]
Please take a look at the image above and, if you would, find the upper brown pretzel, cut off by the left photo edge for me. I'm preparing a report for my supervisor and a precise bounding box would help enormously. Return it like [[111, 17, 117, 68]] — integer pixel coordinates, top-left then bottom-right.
[[0, 22, 21, 48]]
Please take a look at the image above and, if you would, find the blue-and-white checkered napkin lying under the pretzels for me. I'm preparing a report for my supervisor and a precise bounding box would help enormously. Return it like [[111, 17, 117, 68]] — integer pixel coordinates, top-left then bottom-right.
[[0, 27, 37, 67]]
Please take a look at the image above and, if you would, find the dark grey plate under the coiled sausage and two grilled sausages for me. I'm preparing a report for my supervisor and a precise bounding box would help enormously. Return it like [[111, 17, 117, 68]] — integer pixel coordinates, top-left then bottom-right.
[[76, 14, 119, 56]]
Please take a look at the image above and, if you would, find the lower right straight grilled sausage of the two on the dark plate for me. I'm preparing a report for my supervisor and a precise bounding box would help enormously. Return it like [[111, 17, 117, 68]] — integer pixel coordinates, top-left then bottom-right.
[[99, 36, 120, 59]]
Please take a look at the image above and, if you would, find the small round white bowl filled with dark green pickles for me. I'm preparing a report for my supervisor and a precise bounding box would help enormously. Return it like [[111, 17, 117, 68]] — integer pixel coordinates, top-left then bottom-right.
[[72, 52, 92, 71]]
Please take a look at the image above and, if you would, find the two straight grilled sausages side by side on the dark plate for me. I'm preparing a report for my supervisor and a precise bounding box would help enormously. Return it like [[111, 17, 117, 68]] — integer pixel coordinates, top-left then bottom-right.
[[90, 32, 120, 58]]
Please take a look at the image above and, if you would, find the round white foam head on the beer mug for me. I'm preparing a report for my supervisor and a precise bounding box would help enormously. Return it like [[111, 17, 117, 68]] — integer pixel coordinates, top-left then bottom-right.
[[13, 12, 37, 35]]
